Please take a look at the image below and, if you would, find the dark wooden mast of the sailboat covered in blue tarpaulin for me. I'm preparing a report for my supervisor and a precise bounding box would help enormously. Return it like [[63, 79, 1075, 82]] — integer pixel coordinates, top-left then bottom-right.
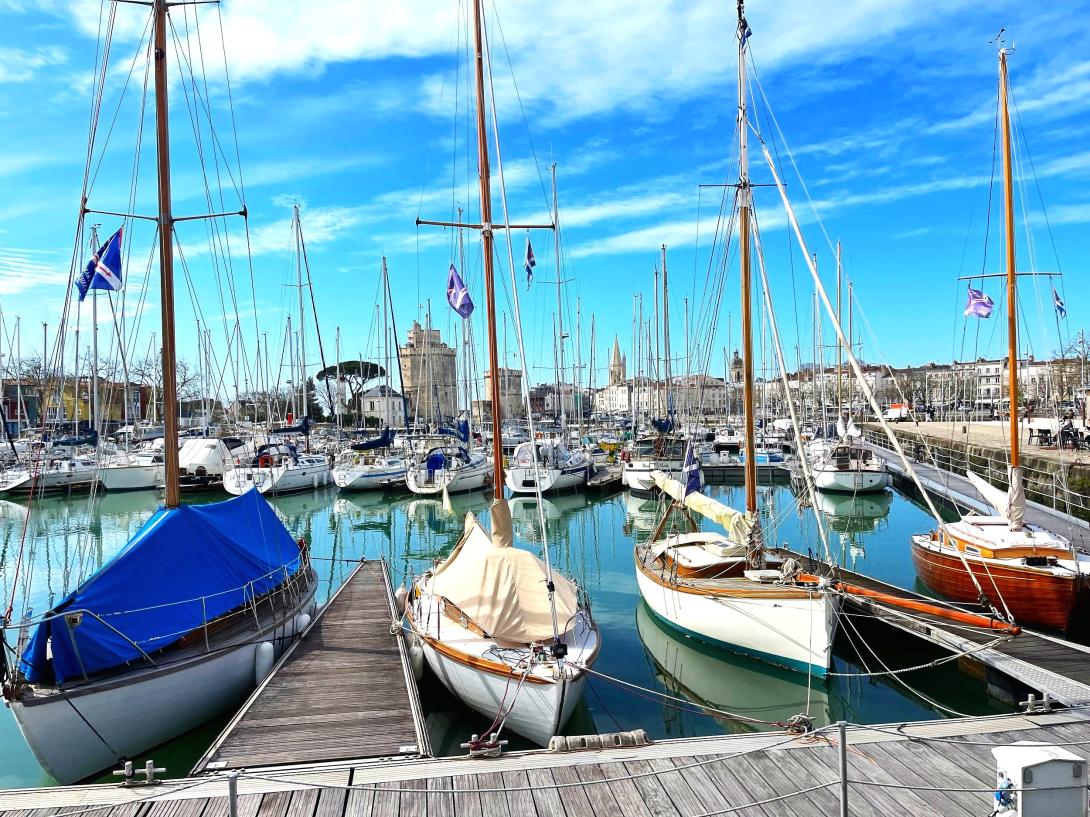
[[152, 0, 179, 508]]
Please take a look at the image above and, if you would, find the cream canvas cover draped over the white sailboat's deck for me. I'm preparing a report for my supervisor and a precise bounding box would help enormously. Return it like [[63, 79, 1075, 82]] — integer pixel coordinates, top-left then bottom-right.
[[425, 500, 579, 644]]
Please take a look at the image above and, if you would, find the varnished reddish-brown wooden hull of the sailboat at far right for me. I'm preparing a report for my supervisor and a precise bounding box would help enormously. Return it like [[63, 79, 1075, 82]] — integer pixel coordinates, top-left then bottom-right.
[[912, 540, 1079, 630]]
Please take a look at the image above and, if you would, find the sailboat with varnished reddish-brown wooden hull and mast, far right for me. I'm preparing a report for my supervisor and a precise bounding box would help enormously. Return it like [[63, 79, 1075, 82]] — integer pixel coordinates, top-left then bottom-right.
[[911, 45, 1090, 630]]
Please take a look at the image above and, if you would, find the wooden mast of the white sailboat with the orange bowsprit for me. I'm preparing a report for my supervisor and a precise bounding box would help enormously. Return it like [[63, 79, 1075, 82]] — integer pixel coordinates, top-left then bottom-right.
[[738, 0, 756, 513]]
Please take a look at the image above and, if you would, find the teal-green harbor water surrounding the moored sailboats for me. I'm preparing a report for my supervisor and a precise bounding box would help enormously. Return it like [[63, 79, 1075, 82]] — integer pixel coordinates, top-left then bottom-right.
[[0, 485, 1005, 788]]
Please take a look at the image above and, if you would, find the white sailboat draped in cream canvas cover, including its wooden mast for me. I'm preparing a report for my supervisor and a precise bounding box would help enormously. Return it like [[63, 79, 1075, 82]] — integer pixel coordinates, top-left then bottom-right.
[[405, 0, 600, 753]]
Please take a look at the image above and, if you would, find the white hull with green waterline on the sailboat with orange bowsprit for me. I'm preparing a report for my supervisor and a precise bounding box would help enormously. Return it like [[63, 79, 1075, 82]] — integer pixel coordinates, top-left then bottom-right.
[[635, 565, 839, 676]]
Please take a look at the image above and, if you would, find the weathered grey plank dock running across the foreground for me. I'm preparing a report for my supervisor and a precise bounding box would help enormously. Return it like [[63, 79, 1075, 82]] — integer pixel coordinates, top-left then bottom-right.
[[8, 709, 1090, 817]]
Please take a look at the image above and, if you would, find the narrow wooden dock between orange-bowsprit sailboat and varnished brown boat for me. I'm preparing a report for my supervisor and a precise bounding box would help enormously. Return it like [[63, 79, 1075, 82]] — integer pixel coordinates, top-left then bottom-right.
[[782, 550, 1090, 706]]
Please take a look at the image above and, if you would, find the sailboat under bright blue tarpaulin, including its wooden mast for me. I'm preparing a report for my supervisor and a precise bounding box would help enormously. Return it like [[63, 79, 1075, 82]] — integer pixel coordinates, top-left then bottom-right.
[[0, 0, 317, 783]]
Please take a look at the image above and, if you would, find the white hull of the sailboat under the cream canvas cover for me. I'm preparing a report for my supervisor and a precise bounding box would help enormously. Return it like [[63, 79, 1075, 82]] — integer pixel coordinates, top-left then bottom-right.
[[422, 639, 586, 746]]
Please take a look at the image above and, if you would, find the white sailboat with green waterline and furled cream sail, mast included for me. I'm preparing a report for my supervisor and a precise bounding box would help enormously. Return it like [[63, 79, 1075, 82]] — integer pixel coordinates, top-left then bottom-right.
[[634, 2, 840, 676]]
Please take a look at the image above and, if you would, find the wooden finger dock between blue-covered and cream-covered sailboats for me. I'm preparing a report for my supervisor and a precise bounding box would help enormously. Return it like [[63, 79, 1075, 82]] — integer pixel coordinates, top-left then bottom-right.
[[193, 560, 431, 775]]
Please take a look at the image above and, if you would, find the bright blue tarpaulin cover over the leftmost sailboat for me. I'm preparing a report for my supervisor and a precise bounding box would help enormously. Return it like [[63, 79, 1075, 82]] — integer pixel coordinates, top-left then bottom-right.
[[20, 490, 302, 683]]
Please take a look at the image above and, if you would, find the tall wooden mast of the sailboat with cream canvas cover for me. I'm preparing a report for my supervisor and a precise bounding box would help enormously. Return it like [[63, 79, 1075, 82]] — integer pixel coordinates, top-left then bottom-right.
[[473, 0, 504, 499]]
